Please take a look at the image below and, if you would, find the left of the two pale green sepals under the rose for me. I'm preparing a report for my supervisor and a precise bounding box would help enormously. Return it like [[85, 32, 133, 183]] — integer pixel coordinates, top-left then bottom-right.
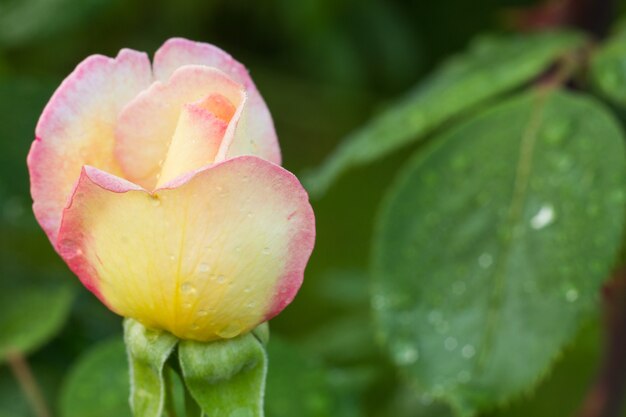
[[124, 319, 178, 417]]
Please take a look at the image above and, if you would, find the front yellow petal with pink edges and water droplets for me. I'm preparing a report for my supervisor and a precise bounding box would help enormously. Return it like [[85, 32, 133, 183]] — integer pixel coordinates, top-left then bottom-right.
[[58, 156, 315, 341]]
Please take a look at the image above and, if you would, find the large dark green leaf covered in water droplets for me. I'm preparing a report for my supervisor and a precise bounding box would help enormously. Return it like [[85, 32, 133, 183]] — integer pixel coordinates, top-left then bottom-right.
[[372, 91, 626, 415]]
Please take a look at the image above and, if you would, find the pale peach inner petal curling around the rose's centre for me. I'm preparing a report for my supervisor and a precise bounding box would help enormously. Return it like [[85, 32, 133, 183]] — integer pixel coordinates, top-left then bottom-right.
[[115, 66, 245, 190]]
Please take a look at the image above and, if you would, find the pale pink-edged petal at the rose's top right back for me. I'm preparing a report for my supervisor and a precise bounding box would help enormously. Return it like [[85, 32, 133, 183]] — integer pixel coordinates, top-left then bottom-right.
[[154, 38, 281, 164]]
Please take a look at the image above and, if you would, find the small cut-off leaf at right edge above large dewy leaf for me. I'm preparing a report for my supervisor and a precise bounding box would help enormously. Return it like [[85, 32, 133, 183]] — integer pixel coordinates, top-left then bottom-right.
[[589, 24, 626, 108]]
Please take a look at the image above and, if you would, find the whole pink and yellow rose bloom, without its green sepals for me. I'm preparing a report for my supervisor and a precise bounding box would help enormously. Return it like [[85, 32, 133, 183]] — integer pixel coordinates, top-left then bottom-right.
[[28, 39, 315, 341]]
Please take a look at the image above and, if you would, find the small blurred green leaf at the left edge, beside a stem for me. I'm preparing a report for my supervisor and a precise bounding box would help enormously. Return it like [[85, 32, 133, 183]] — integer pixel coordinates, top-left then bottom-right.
[[0, 283, 74, 361]]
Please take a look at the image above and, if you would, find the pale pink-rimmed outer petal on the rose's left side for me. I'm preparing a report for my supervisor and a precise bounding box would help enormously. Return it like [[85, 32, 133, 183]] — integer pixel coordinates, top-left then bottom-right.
[[28, 49, 152, 243]]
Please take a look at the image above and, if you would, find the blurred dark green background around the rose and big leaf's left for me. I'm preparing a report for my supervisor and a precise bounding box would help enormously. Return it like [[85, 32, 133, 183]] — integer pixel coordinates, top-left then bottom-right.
[[0, 0, 620, 417]]
